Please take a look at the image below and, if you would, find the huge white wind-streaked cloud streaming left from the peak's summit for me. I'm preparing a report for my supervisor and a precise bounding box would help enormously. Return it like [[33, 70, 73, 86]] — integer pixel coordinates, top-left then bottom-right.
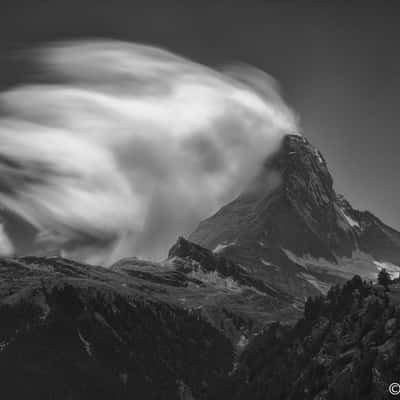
[[0, 41, 296, 264]]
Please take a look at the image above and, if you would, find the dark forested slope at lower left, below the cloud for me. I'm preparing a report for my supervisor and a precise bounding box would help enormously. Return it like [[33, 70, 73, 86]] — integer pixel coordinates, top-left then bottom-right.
[[0, 257, 233, 400]]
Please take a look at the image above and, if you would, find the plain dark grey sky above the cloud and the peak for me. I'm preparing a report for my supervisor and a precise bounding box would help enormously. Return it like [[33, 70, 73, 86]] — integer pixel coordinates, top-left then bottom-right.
[[0, 0, 400, 229]]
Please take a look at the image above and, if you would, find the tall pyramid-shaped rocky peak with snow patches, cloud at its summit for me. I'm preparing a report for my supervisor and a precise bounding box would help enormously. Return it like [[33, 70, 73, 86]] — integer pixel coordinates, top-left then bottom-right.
[[189, 135, 400, 299]]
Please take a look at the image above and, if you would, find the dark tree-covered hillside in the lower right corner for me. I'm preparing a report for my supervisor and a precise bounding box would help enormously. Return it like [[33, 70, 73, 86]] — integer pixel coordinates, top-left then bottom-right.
[[212, 276, 400, 400]]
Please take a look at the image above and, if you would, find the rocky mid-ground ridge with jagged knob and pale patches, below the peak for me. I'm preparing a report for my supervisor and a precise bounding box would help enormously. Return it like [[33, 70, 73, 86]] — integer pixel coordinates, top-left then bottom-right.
[[111, 238, 301, 344]]
